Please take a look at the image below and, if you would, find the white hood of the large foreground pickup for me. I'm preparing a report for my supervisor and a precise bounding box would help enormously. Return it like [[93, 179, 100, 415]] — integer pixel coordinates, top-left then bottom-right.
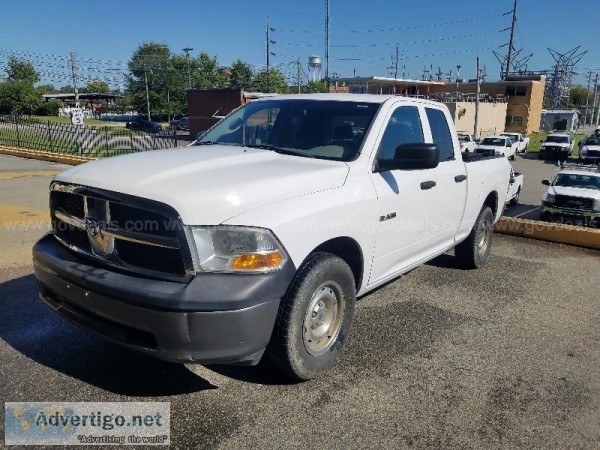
[[55, 145, 349, 225]]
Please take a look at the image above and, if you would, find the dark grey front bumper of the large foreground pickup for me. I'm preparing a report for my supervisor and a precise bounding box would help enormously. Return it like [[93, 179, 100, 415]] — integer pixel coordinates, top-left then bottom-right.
[[33, 235, 295, 365]]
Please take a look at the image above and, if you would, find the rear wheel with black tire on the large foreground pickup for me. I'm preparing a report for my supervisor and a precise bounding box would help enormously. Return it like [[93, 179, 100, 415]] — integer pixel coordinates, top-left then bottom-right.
[[454, 206, 494, 269]]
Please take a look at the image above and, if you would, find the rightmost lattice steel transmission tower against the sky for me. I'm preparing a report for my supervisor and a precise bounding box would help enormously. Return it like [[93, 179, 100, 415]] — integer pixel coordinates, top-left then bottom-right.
[[545, 45, 587, 109]]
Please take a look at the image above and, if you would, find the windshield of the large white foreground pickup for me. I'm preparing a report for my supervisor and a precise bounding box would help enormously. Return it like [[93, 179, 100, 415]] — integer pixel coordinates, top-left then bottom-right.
[[195, 98, 379, 161]]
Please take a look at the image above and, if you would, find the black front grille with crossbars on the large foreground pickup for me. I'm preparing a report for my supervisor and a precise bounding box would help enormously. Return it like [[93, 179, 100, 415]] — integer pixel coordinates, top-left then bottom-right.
[[50, 183, 193, 277]]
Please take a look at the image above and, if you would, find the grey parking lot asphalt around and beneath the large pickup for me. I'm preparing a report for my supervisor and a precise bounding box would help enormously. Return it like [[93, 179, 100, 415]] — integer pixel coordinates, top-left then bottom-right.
[[0, 156, 600, 448]]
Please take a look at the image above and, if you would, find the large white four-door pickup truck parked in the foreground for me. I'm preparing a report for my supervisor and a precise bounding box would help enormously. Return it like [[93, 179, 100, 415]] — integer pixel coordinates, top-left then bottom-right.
[[33, 94, 510, 380]]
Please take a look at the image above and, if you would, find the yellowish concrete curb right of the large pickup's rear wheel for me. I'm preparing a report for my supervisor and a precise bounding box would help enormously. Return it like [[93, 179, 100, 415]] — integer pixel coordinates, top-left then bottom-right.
[[494, 217, 600, 250]]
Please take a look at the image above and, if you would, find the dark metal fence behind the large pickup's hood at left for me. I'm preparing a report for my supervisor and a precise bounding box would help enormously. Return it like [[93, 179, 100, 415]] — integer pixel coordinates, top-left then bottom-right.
[[0, 116, 180, 158]]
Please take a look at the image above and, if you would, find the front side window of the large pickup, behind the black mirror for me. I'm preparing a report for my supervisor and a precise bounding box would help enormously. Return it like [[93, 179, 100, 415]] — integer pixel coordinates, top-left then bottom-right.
[[377, 106, 425, 162]]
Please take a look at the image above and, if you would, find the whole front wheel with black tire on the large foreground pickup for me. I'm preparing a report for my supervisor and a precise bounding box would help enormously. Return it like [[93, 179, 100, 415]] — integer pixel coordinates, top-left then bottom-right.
[[266, 252, 356, 381]]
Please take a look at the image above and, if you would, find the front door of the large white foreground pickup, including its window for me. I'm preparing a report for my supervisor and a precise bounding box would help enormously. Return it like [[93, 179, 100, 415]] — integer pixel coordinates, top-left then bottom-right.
[[369, 103, 439, 284]]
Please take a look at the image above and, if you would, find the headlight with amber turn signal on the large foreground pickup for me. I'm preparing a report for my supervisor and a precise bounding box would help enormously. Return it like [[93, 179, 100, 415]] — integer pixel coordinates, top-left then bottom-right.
[[188, 226, 288, 273]]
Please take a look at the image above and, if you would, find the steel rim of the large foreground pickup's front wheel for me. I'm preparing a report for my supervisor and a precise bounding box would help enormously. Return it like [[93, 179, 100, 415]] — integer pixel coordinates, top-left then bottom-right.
[[302, 281, 346, 356]]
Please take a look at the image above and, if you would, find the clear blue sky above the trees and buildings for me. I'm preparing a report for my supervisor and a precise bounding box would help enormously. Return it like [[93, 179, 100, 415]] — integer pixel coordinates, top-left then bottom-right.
[[0, 0, 600, 87]]
